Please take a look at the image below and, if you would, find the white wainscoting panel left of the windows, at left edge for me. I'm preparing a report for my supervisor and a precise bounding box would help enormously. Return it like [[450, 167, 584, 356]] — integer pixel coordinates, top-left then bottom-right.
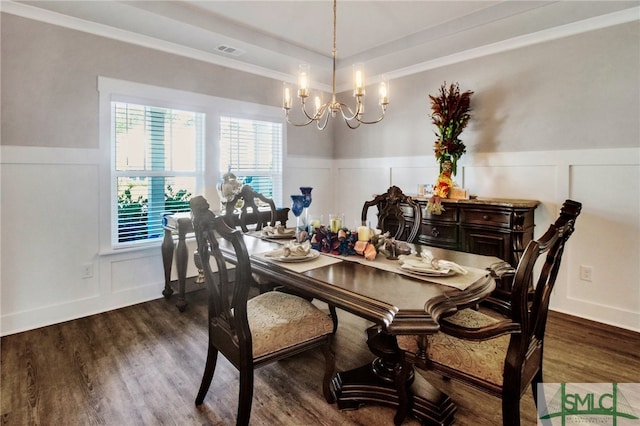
[[2, 164, 98, 316]]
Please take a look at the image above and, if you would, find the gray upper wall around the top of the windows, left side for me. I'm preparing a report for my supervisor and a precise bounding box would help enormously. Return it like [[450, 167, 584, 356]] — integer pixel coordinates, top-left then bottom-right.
[[1, 13, 333, 158]]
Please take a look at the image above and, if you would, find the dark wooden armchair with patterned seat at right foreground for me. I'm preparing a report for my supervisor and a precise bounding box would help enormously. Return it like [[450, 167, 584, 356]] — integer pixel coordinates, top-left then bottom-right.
[[398, 200, 582, 426]]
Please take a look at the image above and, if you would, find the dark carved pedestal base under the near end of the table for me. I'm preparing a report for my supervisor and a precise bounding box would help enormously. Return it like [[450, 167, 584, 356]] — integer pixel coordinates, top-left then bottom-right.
[[333, 328, 456, 426]]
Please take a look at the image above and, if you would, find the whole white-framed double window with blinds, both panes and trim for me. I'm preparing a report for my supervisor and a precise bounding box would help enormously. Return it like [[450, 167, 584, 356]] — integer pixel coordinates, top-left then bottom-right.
[[98, 76, 286, 254]]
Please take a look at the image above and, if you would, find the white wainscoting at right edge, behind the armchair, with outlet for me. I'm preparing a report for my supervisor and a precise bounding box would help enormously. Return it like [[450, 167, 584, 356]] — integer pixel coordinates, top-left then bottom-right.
[[562, 164, 640, 328]]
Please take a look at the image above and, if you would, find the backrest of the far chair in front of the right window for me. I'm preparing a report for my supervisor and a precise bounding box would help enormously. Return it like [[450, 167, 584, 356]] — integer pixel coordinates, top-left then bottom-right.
[[225, 185, 276, 232]]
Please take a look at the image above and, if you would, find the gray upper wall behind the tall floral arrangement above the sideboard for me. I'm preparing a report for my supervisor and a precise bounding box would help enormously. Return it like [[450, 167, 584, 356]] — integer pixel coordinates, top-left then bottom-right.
[[335, 21, 640, 158]]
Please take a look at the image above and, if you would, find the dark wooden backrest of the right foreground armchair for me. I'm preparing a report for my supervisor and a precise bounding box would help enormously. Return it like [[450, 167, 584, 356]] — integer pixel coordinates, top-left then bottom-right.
[[504, 200, 582, 386]]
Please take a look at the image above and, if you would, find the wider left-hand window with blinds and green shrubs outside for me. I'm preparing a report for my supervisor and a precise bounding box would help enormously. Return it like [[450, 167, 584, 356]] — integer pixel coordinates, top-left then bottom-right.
[[111, 102, 205, 247]]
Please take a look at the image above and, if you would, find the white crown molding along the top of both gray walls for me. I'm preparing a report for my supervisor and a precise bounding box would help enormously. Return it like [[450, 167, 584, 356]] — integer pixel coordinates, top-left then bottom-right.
[[0, 1, 640, 92]]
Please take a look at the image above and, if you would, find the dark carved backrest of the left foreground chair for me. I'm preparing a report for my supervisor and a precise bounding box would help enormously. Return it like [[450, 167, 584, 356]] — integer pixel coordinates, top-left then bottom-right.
[[190, 196, 253, 367]]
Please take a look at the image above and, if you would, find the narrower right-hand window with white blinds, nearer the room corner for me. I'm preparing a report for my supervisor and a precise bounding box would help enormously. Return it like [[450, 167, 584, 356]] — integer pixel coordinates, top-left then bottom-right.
[[220, 116, 283, 205]]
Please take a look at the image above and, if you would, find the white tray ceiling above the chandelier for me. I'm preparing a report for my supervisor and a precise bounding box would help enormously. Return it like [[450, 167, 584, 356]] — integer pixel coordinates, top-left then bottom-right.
[[2, 0, 640, 89]]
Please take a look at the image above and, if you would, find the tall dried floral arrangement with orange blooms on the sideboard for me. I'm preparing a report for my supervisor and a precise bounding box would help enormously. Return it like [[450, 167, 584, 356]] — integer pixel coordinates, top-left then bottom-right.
[[427, 82, 473, 214]]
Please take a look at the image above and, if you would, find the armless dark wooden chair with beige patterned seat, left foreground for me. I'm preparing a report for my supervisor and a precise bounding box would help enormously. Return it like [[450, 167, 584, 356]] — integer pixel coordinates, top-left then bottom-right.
[[191, 196, 335, 425]]
